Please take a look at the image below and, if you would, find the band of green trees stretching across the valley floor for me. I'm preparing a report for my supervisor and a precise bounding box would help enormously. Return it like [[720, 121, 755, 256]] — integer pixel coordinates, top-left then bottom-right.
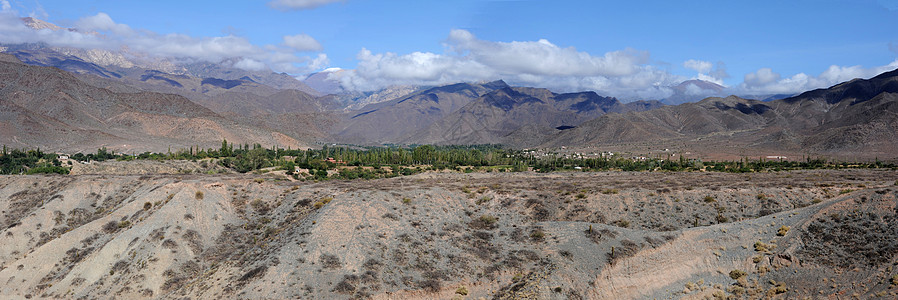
[[0, 140, 896, 179]]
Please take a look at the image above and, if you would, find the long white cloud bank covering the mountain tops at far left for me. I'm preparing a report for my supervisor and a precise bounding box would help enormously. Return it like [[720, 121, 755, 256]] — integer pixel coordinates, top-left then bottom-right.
[[0, 11, 327, 73]]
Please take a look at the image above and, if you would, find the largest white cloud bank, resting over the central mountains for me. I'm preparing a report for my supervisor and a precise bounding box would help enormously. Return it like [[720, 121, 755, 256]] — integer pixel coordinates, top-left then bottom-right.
[[333, 30, 683, 99]]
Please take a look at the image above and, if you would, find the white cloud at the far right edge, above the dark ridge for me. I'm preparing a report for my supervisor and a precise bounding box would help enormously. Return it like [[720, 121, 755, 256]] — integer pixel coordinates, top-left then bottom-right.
[[737, 60, 898, 95]]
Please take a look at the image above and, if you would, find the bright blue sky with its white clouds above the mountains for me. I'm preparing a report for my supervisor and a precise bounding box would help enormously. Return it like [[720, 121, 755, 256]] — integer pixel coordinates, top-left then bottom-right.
[[0, 0, 898, 99]]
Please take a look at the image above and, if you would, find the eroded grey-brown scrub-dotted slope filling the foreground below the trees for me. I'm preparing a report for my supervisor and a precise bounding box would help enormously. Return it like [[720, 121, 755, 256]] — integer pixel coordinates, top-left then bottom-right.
[[0, 170, 898, 299]]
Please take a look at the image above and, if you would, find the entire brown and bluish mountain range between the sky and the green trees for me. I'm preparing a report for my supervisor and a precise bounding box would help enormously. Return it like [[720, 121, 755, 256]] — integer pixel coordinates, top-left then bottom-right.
[[0, 19, 898, 158]]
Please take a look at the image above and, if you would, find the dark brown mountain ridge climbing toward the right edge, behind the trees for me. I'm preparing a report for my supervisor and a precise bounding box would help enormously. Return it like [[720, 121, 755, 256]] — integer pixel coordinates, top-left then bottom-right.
[[543, 70, 898, 157]]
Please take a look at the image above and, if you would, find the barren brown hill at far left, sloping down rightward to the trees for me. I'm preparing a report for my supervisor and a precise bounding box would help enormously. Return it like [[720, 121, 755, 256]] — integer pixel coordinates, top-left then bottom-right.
[[0, 56, 305, 152]]
